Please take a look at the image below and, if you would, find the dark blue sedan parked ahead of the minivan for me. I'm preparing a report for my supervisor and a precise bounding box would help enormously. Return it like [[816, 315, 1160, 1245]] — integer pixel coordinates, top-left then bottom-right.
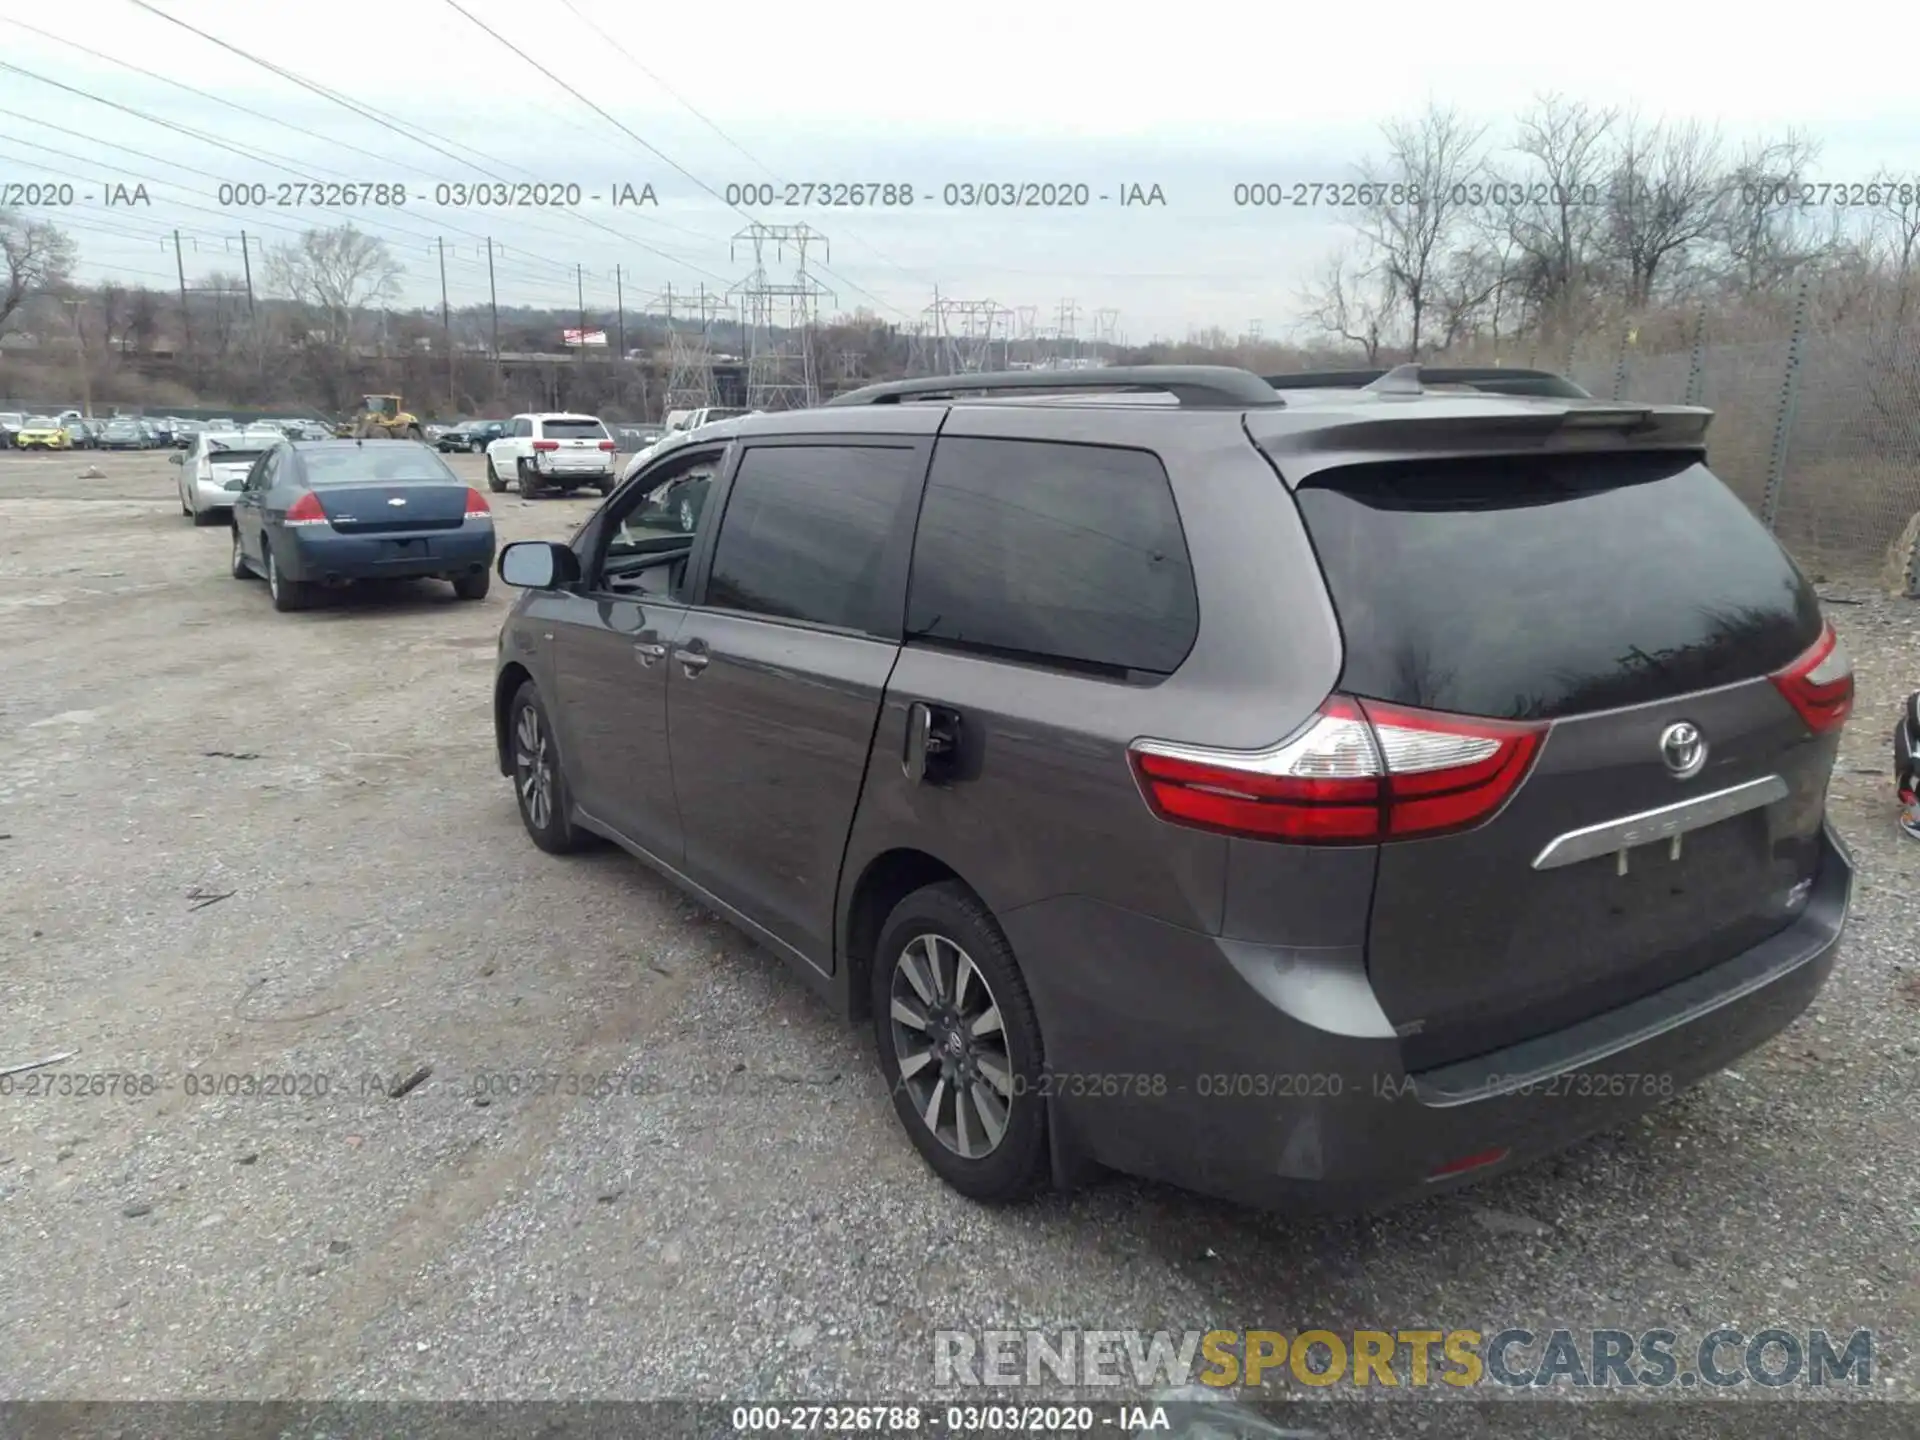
[[228, 440, 495, 611]]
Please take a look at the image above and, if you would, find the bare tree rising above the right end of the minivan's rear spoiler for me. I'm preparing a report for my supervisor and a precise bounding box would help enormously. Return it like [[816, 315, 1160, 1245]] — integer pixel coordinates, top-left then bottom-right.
[[1605, 115, 1726, 309]]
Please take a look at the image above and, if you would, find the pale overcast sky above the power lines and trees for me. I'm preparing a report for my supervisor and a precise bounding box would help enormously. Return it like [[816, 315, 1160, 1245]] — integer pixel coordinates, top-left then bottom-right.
[[0, 0, 1920, 340]]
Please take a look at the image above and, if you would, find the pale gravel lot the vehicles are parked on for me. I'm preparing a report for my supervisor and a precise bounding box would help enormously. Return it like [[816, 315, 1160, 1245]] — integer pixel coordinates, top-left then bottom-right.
[[0, 445, 1920, 1400]]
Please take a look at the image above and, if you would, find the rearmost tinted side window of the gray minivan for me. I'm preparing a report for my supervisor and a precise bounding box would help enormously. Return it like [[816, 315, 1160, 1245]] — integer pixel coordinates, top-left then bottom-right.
[[906, 438, 1200, 676]]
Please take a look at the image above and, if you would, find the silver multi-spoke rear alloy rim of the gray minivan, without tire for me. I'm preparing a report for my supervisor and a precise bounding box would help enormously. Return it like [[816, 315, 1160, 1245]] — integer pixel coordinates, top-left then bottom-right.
[[889, 933, 1014, 1160]]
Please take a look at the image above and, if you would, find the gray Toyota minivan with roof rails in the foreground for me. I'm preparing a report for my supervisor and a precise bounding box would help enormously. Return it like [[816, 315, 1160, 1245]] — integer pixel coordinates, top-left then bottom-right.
[[493, 367, 1853, 1208]]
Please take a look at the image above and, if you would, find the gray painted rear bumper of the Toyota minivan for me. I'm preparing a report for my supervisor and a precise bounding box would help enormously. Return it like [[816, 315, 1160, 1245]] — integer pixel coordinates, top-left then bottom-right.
[[1004, 829, 1853, 1210]]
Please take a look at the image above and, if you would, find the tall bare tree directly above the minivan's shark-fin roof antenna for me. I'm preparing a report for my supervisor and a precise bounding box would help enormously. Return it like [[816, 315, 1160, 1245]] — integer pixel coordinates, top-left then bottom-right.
[[1354, 106, 1486, 359]]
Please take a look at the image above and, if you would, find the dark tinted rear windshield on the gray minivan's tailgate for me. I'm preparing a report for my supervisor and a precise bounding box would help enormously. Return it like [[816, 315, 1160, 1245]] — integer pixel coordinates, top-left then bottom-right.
[[1296, 455, 1820, 720]]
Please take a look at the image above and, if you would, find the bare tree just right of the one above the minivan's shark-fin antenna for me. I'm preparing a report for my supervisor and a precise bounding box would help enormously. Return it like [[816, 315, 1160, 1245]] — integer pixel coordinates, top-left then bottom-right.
[[1507, 94, 1619, 330]]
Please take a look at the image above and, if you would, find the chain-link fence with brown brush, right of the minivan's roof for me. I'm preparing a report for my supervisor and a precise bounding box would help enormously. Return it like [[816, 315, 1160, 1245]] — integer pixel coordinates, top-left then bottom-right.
[[1559, 301, 1920, 582]]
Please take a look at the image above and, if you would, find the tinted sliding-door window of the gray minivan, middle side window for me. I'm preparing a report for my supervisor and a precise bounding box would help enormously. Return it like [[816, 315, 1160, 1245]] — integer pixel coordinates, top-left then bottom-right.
[[707, 445, 925, 634]]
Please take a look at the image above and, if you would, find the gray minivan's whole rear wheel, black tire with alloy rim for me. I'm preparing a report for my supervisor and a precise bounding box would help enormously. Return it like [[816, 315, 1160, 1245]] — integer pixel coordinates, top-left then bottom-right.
[[872, 881, 1050, 1204]]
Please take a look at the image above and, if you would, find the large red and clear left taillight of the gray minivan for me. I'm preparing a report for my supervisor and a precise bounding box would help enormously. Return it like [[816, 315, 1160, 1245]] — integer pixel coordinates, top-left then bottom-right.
[[1131, 695, 1546, 845]]
